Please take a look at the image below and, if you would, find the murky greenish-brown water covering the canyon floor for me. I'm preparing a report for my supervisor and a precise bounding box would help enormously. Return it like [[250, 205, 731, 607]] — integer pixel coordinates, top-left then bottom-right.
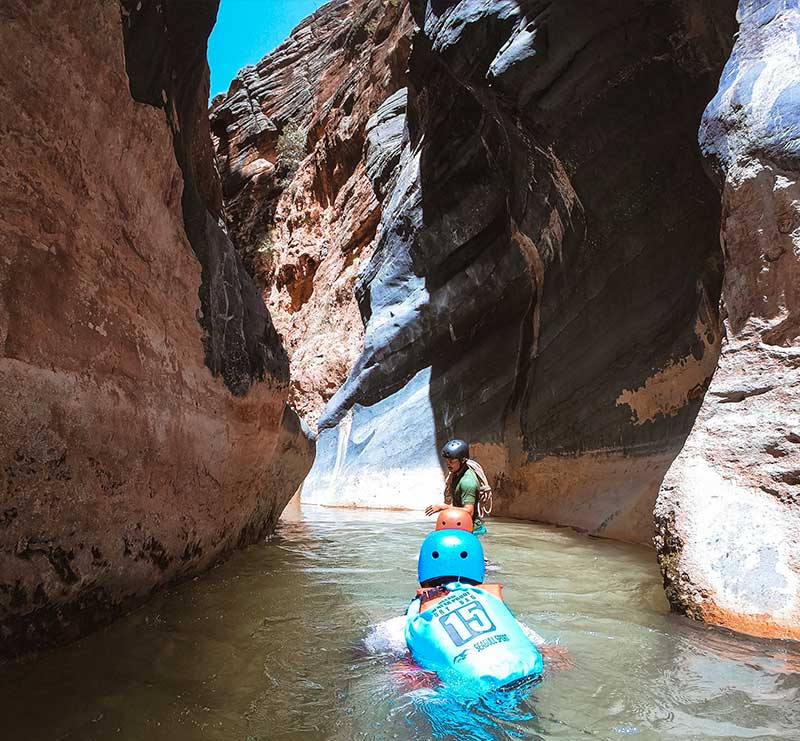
[[0, 507, 800, 741]]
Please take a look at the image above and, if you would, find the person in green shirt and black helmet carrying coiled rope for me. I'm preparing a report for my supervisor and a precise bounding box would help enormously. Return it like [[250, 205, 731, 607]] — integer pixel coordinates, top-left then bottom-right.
[[425, 440, 491, 535]]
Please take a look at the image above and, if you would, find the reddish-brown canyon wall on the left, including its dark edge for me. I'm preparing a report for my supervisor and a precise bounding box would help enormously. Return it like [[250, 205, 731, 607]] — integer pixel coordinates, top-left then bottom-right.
[[0, 0, 313, 656]]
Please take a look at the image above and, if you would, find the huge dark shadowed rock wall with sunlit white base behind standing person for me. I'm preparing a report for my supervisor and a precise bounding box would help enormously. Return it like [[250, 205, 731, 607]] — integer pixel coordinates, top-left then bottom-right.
[[303, 0, 735, 542]]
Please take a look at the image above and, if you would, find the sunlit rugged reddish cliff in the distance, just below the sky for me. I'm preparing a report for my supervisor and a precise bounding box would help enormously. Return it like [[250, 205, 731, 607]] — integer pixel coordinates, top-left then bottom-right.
[[210, 0, 411, 427]]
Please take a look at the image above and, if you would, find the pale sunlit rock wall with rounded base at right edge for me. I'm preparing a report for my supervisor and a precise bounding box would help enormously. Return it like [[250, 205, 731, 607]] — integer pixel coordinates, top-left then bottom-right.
[[656, 0, 800, 639]]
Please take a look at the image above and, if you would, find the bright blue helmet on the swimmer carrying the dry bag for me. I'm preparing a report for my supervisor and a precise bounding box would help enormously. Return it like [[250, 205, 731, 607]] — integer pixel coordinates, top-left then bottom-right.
[[417, 530, 486, 584]]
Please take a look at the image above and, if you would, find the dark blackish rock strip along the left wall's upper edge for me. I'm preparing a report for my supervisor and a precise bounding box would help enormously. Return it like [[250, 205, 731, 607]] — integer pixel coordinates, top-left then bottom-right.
[[121, 0, 289, 395]]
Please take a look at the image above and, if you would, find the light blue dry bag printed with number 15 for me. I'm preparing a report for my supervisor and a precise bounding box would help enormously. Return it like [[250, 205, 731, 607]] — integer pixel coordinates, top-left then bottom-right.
[[406, 582, 544, 695]]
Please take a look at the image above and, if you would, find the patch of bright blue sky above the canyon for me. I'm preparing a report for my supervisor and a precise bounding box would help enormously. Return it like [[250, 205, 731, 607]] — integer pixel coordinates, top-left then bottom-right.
[[208, 0, 327, 98]]
